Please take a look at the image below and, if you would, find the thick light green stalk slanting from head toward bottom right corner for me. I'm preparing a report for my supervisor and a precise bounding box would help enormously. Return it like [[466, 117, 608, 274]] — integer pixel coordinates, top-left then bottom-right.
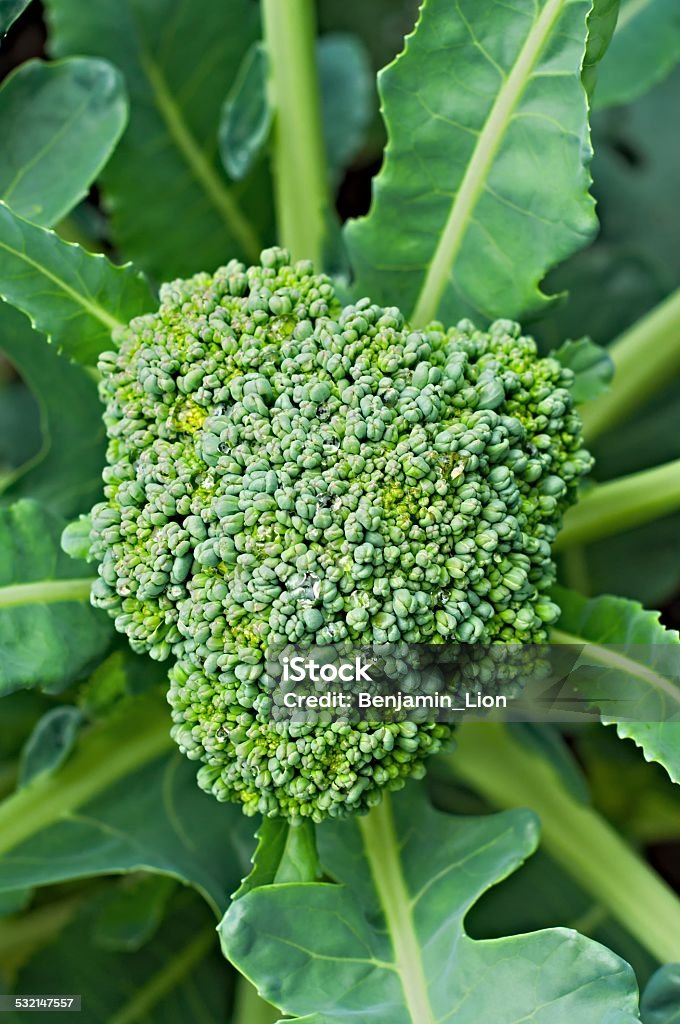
[[444, 722, 680, 963]]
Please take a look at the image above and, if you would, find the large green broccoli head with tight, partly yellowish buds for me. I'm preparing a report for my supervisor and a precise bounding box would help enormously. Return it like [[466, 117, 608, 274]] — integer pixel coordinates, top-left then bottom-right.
[[85, 249, 591, 820]]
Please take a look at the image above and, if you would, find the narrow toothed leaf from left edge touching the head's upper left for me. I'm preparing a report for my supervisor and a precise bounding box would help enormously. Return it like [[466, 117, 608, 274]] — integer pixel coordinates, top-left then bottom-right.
[[0, 203, 154, 362]]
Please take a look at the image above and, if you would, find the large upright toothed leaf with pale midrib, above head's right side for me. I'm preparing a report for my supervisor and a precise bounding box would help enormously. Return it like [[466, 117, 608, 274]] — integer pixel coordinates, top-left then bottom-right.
[[347, 0, 596, 325]]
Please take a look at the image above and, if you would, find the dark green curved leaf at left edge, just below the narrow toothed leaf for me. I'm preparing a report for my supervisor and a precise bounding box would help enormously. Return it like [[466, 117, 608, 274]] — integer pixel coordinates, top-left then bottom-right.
[[0, 306, 105, 517]]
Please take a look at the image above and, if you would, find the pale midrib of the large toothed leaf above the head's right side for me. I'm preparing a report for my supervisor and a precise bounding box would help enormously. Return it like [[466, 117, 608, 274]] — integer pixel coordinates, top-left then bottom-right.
[[411, 0, 565, 327]]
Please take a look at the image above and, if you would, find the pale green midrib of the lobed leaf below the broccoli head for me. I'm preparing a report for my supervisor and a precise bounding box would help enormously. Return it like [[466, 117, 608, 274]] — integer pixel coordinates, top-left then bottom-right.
[[357, 795, 435, 1024]]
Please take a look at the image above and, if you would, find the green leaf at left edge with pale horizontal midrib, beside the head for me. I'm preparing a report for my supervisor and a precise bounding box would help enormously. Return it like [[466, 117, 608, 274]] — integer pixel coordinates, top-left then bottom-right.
[[0, 500, 112, 694]]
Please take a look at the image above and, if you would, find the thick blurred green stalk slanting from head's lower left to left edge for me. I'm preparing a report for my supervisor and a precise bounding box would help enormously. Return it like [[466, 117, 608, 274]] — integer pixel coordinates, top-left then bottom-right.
[[0, 695, 174, 854]]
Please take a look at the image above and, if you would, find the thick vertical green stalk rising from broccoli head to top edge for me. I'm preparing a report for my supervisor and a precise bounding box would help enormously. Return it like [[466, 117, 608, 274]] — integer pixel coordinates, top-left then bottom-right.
[[262, 0, 329, 268]]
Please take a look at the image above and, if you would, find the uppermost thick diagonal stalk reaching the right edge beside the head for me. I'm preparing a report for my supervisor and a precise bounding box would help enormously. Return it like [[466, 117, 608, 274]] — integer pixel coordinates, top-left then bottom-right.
[[582, 290, 680, 441]]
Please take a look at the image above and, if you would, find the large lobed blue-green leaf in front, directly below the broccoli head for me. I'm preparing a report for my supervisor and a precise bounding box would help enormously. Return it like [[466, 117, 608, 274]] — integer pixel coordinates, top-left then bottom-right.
[[220, 786, 638, 1024]]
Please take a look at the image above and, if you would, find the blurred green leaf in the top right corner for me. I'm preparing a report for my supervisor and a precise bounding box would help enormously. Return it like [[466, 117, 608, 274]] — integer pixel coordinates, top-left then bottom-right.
[[594, 0, 680, 106]]
